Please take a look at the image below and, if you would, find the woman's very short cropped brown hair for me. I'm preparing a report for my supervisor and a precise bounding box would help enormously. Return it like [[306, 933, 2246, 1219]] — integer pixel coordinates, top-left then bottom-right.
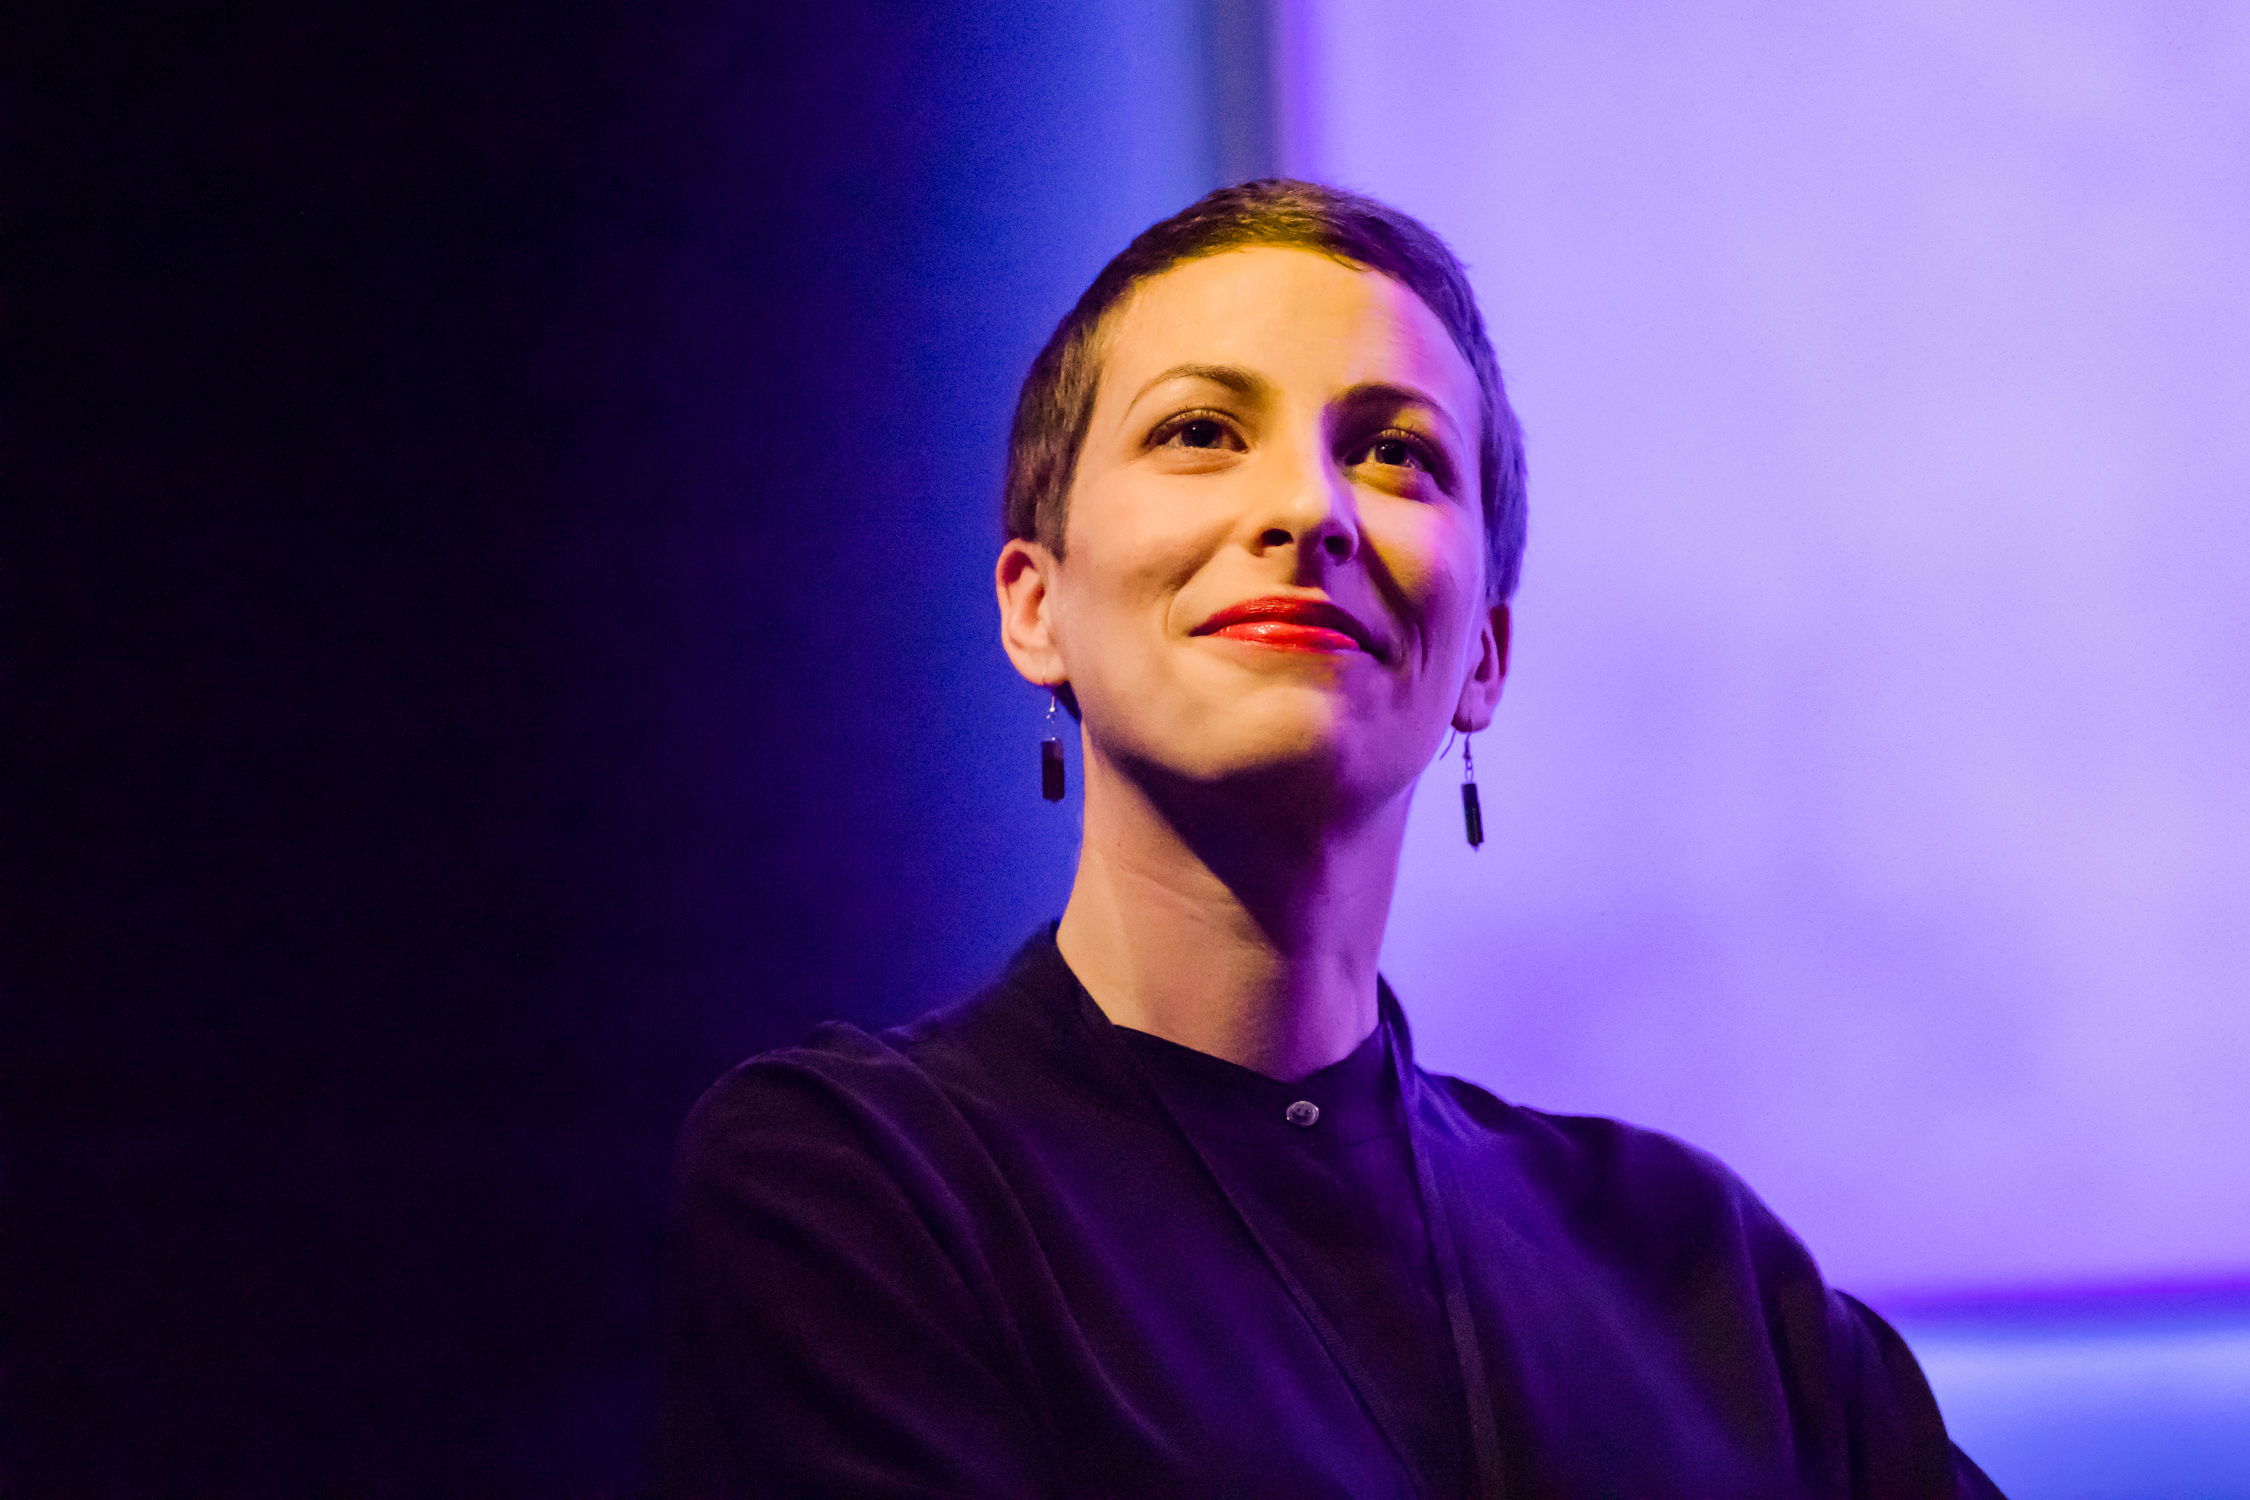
[[1004, 178, 1526, 603]]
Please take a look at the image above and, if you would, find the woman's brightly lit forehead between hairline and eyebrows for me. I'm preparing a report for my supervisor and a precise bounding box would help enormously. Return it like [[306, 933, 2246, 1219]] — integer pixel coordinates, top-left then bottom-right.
[[1098, 245, 1478, 420]]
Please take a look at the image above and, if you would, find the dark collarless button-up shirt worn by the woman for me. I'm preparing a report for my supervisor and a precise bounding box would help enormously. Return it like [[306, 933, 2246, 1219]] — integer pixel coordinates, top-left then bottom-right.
[[659, 929, 1994, 1498]]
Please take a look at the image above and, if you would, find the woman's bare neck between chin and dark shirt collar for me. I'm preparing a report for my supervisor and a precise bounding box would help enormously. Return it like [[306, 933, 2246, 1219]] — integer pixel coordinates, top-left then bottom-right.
[[1055, 744, 1411, 1079]]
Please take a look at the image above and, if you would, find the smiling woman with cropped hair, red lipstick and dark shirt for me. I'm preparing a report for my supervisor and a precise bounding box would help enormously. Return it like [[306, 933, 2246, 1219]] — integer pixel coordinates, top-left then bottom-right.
[[664, 182, 1991, 1496]]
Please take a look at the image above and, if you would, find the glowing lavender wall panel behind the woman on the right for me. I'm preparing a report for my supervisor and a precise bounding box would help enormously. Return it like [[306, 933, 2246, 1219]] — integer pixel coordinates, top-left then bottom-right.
[[1278, 0, 2250, 1293]]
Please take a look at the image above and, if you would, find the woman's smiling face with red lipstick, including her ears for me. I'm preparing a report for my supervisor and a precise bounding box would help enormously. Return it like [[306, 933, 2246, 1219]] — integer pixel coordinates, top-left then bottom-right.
[[999, 247, 1508, 807]]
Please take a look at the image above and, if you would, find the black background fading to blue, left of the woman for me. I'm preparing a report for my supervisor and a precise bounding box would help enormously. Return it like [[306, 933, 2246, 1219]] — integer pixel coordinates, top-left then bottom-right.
[[0, 0, 1262, 1496]]
